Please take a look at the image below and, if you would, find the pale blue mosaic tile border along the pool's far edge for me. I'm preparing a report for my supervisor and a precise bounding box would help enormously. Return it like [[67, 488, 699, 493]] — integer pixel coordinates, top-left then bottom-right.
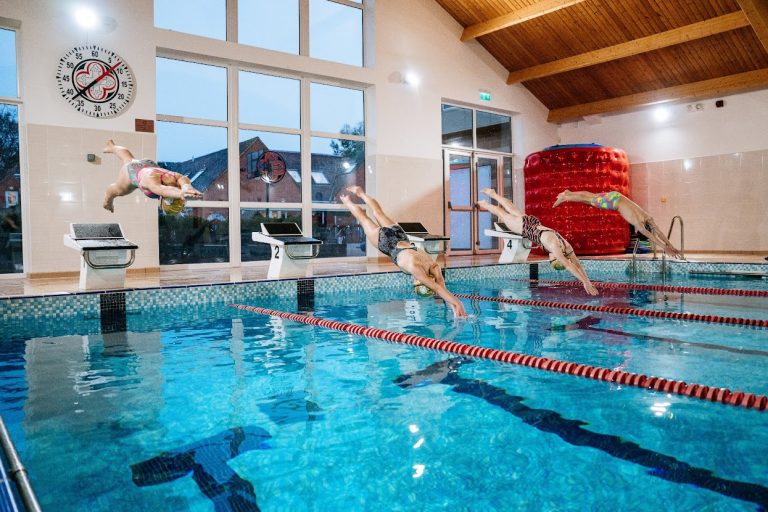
[[0, 259, 768, 321]]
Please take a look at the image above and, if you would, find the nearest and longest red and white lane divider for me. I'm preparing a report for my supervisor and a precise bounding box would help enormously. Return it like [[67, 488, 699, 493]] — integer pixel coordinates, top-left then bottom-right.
[[230, 304, 768, 411]]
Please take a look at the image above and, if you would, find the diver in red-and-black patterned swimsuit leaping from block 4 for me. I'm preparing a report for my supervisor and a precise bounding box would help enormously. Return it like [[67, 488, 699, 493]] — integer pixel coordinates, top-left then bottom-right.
[[477, 188, 597, 295]]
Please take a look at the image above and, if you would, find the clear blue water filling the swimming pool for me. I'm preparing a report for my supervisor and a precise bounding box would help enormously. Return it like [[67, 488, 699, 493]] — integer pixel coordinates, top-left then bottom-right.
[[0, 276, 768, 512]]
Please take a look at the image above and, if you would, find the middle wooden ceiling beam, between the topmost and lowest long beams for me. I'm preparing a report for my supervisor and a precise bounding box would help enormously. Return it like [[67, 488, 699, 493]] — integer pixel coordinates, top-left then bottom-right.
[[507, 11, 748, 84]]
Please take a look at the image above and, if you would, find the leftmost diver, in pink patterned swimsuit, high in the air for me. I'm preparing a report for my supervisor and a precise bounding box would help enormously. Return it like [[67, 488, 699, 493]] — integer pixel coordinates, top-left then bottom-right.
[[104, 140, 203, 213]]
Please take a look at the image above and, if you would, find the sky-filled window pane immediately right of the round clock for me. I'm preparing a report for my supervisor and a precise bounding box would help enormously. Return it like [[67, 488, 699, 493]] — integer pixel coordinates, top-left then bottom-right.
[[157, 57, 227, 121]]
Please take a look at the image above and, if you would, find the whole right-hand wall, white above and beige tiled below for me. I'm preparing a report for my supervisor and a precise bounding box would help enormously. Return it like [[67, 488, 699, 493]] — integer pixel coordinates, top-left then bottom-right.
[[559, 90, 768, 253]]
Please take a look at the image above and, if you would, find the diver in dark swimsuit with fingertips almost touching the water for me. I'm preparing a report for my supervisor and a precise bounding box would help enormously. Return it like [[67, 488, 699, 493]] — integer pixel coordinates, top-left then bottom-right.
[[339, 186, 467, 318]]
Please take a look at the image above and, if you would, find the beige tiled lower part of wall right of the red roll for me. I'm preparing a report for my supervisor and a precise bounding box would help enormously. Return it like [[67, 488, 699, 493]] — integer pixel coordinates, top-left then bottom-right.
[[630, 150, 768, 252]]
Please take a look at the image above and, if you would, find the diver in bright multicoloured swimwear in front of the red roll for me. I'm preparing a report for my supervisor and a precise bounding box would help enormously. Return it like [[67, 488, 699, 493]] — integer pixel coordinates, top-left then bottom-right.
[[552, 190, 684, 259]]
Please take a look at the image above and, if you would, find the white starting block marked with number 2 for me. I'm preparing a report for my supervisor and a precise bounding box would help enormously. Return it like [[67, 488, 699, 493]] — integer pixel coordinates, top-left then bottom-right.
[[251, 222, 323, 279]]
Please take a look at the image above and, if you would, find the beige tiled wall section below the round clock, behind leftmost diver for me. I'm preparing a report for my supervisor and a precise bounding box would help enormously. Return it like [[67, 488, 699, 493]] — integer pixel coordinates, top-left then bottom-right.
[[24, 124, 159, 273]]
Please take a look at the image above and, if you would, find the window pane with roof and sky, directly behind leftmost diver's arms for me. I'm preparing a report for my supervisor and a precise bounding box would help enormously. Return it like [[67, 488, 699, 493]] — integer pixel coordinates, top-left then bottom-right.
[[157, 121, 228, 199]]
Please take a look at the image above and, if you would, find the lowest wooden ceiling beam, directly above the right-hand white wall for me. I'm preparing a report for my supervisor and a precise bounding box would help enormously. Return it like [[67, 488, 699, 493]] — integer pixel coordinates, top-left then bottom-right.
[[547, 68, 768, 123]]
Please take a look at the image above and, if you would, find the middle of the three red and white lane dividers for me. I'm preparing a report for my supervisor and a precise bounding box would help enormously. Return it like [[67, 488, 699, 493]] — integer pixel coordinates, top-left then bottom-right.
[[456, 293, 768, 327]]
